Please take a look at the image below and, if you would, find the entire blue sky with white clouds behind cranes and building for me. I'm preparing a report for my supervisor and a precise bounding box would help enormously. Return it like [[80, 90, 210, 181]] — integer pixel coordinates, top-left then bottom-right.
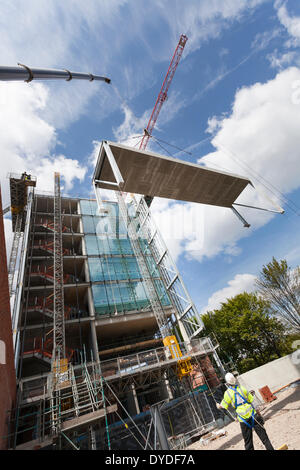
[[0, 0, 300, 311]]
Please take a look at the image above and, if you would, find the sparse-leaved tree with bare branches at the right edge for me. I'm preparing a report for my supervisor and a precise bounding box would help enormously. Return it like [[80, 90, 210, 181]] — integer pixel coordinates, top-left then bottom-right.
[[256, 257, 300, 333]]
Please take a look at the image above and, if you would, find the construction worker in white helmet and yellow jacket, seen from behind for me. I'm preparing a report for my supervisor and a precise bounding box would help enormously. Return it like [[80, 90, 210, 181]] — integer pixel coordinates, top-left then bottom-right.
[[217, 373, 274, 450]]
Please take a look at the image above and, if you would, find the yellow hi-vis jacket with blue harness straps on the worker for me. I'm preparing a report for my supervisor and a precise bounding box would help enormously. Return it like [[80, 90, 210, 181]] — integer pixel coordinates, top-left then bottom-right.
[[221, 385, 255, 422]]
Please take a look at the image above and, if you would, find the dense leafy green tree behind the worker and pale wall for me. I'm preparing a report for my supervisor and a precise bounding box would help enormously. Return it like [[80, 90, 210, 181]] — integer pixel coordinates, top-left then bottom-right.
[[202, 292, 291, 373]]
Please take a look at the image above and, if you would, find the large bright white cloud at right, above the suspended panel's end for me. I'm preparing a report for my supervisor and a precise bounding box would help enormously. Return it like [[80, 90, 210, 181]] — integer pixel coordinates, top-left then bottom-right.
[[201, 67, 300, 192]]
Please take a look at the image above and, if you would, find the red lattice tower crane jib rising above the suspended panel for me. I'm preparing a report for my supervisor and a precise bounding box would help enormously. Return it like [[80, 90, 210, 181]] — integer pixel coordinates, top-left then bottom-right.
[[139, 34, 188, 207]]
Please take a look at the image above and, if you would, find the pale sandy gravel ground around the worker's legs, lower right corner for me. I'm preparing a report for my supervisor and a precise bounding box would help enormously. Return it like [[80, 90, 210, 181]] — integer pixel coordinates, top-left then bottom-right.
[[187, 385, 300, 450]]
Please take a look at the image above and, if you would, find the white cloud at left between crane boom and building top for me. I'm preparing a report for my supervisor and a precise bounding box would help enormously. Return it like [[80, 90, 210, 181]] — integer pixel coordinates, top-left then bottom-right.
[[0, 83, 86, 262]]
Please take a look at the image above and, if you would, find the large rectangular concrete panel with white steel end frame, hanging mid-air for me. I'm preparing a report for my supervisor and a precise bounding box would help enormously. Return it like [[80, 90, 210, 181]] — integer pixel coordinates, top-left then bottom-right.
[[94, 141, 251, 207]]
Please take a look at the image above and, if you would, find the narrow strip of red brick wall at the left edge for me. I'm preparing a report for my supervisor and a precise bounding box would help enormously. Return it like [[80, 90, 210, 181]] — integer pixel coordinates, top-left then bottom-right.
[[0, 188, 16, 449]]
